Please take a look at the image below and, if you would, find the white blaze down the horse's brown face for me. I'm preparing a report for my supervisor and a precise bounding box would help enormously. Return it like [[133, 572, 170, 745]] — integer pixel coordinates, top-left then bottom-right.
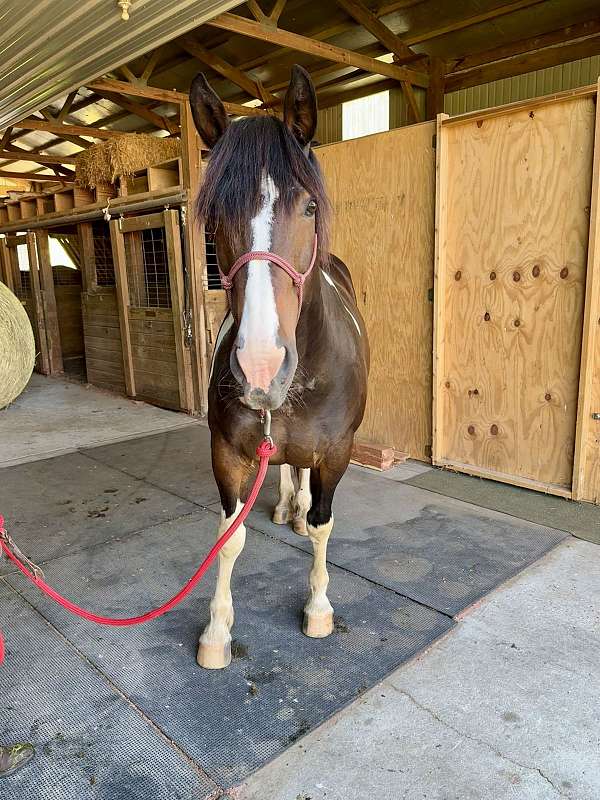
[[240, 175, 279, 347]]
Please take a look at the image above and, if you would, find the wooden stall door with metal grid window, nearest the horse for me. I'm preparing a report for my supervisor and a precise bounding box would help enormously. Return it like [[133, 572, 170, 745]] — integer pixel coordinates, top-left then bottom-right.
[[111, 210, 193, 410]]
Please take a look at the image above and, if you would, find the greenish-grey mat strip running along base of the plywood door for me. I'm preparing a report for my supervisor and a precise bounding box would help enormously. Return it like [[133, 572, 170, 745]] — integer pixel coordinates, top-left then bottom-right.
[[407, 469, 600, 544]]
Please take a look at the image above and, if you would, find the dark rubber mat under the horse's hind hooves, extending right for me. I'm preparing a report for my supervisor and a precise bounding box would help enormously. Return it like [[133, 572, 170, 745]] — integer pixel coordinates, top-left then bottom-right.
[[240, 467, 568, 615]]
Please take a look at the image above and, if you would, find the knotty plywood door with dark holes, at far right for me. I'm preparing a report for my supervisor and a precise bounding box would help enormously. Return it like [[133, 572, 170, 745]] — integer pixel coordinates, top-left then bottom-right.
[[434, 96, 594, 495]]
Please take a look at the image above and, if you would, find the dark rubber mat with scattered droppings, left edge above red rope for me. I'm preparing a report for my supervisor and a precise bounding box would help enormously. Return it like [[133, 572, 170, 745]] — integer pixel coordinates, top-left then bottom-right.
[[0, 453, 197, 573]]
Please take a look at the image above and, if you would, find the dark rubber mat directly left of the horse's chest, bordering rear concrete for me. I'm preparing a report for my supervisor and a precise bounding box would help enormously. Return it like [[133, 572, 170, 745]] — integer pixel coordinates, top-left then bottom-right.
[[82, 425, 219, 505]]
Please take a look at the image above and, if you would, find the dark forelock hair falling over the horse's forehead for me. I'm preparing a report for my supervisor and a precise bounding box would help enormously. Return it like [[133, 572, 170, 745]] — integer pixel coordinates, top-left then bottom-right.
[[196, 116, 330, 264]]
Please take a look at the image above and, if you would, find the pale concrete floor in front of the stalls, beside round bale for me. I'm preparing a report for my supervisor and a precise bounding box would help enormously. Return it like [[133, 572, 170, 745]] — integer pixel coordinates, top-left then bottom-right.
[[0, 373, 198, 467]]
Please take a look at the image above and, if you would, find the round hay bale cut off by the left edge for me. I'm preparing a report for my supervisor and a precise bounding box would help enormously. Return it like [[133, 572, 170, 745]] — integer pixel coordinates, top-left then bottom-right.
[[0, 282, 35, 408]]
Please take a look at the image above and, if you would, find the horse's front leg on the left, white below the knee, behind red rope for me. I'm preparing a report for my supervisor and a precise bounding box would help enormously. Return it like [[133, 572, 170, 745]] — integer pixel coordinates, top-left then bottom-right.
[[197, 434, 251, 669]]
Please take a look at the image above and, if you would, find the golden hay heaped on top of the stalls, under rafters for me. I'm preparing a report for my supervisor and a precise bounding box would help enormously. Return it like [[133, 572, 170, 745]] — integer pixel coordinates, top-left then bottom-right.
[[75, 133, 181, 189]]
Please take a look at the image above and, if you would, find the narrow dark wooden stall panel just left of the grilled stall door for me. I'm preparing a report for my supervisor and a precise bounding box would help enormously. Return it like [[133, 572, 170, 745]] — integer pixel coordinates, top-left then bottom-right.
[[79, 221, 125, 394]]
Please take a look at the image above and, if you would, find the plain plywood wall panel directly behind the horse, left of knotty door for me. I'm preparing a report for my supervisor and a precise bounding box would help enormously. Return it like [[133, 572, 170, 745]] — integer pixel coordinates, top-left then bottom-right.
[[316, 122, 435, 460]]
